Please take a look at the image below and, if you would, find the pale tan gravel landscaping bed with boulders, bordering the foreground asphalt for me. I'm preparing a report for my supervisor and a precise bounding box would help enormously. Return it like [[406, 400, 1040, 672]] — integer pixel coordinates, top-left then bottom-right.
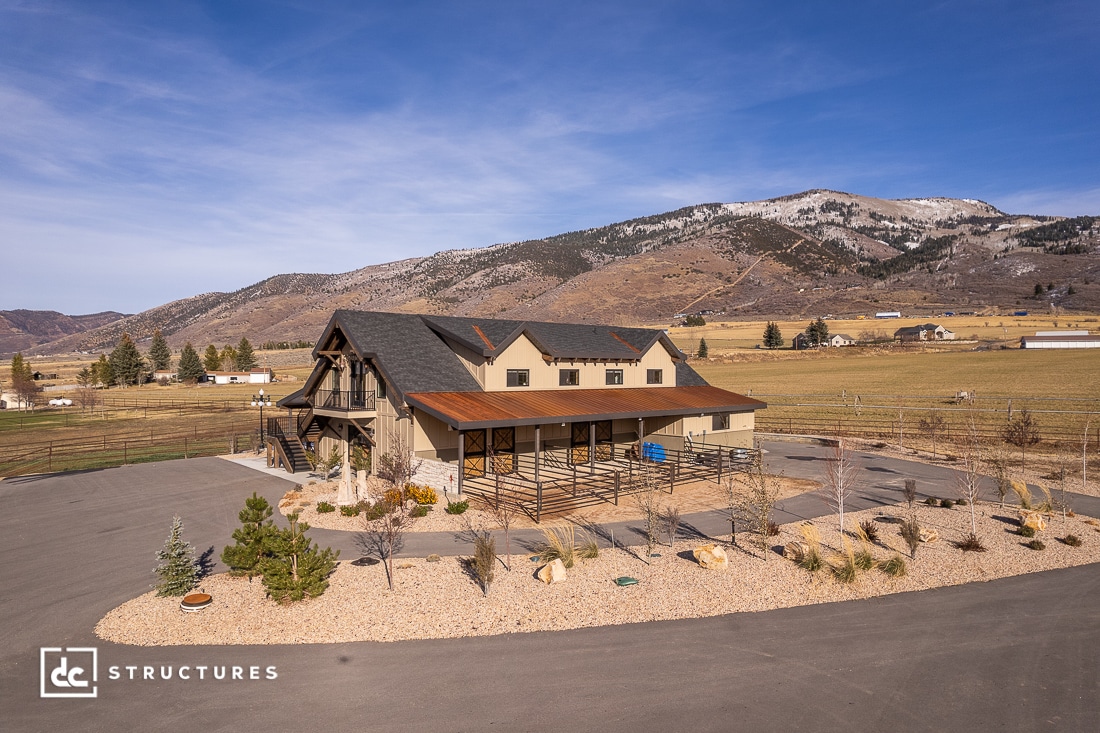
[[96, 504, 1100, 646]]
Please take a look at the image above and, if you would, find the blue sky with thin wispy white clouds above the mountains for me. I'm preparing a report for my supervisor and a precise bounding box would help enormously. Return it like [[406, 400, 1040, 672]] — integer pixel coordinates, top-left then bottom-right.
[[0, 0, 1100, 314]]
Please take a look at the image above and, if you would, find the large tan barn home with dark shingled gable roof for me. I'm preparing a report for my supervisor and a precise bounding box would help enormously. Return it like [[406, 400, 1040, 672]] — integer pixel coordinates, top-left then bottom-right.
[[275, 310, 766, 512]]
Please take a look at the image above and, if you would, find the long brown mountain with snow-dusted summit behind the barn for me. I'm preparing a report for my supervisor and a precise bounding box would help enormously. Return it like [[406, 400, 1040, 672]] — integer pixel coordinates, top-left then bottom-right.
[[21, 190, 1100, 352]]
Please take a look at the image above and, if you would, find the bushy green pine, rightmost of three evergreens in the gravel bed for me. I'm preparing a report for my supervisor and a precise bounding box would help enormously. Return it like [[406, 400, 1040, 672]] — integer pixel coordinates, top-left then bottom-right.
[[263, 513, 340, 603]]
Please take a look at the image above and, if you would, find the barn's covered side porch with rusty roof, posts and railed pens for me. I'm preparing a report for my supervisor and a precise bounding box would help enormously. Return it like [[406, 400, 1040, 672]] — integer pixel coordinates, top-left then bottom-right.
[[407, 386, 766, 522]]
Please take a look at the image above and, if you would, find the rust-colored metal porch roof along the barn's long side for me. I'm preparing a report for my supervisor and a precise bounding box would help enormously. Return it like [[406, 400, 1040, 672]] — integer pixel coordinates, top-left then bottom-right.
[[405, 386, 768, 430]]
